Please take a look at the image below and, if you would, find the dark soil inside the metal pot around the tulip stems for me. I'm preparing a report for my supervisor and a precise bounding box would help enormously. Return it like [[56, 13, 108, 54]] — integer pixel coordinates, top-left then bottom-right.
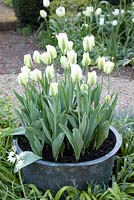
[[18, 134, 115, 163]]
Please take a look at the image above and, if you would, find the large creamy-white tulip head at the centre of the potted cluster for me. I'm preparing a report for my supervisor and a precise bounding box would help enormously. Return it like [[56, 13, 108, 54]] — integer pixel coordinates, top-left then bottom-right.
[[71, 64, 82, 82]]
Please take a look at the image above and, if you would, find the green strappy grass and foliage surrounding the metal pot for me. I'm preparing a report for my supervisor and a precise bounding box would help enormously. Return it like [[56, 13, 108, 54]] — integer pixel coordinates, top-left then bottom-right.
[[0, 99, 134, 200]]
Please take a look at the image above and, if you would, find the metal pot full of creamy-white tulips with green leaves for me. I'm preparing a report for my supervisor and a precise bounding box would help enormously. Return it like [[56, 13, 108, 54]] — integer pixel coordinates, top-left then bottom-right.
[[5, 33, 121, 190]]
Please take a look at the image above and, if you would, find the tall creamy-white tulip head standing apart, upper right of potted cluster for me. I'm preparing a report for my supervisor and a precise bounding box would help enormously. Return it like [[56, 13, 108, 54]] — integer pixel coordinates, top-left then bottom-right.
[[83, 35, 95, 51]]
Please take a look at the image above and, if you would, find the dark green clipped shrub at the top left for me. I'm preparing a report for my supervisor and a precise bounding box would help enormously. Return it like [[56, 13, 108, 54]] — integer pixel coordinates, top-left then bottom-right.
[[13, 0, 44, 26]]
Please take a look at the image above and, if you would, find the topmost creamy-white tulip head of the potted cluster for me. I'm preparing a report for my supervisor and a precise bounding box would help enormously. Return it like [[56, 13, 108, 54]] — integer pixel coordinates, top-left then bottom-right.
[[56, 33, 69, 51]]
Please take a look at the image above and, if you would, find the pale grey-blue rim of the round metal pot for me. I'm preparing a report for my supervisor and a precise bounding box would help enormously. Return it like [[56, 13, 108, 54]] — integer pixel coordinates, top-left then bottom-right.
[[13, 126, 122, 167]]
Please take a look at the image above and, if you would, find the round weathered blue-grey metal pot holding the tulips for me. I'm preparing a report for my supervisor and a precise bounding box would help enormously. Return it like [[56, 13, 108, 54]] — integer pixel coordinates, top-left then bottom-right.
[[13, 126, 122, 191]]
